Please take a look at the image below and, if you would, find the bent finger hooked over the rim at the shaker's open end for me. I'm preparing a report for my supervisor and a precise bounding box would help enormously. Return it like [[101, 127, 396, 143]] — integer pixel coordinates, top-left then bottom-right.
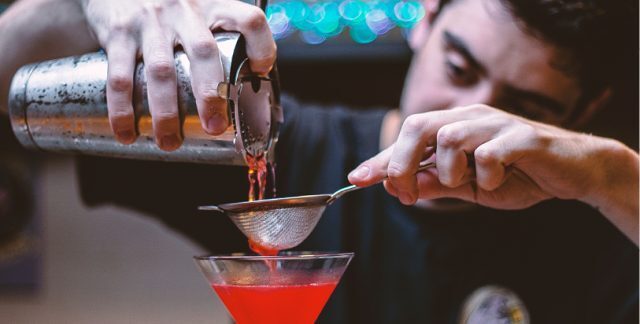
[[209, 1, 276, 74]]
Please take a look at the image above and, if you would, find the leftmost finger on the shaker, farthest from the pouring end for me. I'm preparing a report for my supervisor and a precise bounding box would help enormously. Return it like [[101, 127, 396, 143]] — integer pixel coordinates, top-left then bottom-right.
[[107, 35, 136, 144]]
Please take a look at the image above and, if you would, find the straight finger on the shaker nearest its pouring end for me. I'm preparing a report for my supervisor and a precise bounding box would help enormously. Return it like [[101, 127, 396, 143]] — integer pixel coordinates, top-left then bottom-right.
[[174, 6, 229, 135]]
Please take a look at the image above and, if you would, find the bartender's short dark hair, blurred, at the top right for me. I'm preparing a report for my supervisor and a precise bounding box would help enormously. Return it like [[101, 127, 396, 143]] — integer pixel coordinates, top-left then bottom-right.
[[440, 0, 638, 105]]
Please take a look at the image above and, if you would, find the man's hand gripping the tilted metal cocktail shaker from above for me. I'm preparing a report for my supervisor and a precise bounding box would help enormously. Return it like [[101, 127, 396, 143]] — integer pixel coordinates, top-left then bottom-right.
[[83, 0, 276, 151]]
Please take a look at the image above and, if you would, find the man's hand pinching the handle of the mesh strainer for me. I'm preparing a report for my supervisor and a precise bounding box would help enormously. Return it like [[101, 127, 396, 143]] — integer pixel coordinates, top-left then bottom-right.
[[349, 105, 638, 244]]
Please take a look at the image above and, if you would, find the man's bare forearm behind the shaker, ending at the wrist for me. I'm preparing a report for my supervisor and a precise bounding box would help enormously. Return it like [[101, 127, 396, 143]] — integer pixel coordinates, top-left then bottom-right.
[[0, 0, 98, 113]]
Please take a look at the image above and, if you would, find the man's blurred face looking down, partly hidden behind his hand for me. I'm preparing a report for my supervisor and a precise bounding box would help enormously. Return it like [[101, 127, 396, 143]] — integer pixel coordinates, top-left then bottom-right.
[[401, 0, 580, 124]]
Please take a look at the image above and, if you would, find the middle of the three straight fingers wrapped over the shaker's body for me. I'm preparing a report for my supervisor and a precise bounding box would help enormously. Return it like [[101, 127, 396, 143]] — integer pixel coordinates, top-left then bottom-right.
[[142, 7, 182, 151]]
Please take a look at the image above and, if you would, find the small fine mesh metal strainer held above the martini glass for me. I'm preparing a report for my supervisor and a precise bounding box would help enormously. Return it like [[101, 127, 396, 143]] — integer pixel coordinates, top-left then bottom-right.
[[198, 163, 435, 251]]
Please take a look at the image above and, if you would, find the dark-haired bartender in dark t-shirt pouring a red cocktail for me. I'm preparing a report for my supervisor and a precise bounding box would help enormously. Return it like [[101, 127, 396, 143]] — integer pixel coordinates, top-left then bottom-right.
[[0, 0, 638, 323]]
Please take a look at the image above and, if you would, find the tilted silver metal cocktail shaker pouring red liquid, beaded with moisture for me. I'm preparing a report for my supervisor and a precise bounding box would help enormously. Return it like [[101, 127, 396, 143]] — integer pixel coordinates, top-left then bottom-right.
[[9, 32, 283, 165]]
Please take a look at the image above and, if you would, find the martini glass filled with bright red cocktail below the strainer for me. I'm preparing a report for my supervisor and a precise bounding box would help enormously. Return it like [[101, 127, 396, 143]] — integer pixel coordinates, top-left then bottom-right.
[[195, 252, 353, 324]]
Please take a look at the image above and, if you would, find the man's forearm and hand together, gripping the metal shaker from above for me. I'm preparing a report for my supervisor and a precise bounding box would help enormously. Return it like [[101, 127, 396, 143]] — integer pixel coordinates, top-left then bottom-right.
[[0, 0, 276, 151]]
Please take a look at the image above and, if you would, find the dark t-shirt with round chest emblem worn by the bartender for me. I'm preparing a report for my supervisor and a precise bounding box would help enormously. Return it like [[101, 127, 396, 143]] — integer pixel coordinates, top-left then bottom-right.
[[79, 97, 638, 323]]
